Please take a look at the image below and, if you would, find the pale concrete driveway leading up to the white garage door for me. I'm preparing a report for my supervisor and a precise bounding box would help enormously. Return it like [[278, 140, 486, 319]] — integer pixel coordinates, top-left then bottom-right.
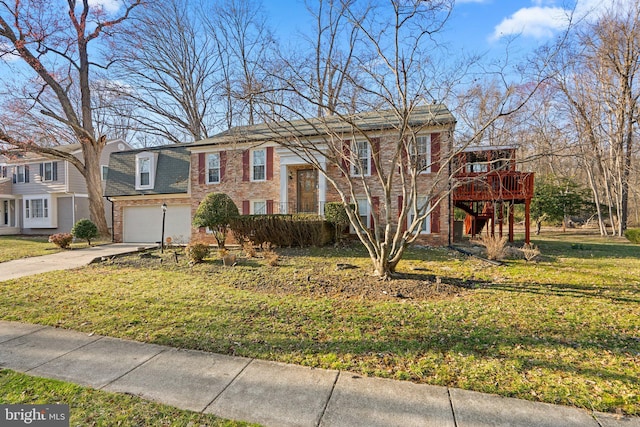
[[0, 243, 152, 282]]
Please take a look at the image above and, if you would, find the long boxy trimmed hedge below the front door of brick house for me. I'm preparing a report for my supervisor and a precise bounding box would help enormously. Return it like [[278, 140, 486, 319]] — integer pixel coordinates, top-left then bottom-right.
[[231, 214, 332, 247]]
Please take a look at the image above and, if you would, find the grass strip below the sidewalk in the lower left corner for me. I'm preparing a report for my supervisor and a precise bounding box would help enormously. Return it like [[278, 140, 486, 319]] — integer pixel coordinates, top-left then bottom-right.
[[0, 369, 255, 427]]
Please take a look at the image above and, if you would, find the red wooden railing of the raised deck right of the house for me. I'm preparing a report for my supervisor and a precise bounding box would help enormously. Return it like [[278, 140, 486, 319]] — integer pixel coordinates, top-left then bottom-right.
[[453, 171, 534, 201]]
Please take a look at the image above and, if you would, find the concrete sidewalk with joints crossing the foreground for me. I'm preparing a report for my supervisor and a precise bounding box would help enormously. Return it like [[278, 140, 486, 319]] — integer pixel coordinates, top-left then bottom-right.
[[0, 321, 640, 427]]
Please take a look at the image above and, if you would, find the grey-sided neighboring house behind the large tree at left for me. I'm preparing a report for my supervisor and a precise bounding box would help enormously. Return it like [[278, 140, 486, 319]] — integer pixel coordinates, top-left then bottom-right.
[[0, 140, 131, 234]]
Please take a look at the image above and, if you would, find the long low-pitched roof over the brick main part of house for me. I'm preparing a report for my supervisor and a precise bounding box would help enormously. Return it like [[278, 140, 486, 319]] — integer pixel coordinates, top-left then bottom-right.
[[191, 104, 456, 147]]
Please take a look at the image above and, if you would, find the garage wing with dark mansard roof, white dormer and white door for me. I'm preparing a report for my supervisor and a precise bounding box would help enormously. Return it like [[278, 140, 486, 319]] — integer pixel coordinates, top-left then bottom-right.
[[104, 145, 191, 243]]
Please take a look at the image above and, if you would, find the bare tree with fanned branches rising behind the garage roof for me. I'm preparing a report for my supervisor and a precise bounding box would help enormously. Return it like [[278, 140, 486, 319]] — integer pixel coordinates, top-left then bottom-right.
[[113, 0, 221, 143]]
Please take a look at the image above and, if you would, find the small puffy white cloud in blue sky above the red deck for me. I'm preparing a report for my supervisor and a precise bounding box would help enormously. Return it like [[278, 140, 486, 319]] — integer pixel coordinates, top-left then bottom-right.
[[491, 6, 568, 40]]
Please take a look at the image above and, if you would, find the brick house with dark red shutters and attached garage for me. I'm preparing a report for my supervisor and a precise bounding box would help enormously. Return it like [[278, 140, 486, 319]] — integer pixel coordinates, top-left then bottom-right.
[[106, 105, 455, 245]]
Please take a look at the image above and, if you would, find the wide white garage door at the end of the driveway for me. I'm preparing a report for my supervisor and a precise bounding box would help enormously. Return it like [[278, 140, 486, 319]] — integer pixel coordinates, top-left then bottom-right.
[[123, 205, 191, 243]]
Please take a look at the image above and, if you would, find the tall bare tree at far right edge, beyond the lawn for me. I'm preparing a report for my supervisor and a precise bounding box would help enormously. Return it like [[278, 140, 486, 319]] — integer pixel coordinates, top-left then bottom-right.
[[544, 3, 640, 235]]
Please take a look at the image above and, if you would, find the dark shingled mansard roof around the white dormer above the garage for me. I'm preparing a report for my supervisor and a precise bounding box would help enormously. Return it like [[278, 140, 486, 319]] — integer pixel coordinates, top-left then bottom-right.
[[104, 144, 190, 197]]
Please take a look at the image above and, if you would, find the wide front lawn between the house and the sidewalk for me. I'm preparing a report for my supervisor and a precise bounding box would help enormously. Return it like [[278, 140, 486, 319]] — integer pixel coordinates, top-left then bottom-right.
[[0, 232, 640, 414]]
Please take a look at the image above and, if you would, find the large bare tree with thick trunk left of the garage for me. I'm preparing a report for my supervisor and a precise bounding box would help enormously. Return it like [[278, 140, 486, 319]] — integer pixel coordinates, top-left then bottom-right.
[[0, 0, 141, 235]]
